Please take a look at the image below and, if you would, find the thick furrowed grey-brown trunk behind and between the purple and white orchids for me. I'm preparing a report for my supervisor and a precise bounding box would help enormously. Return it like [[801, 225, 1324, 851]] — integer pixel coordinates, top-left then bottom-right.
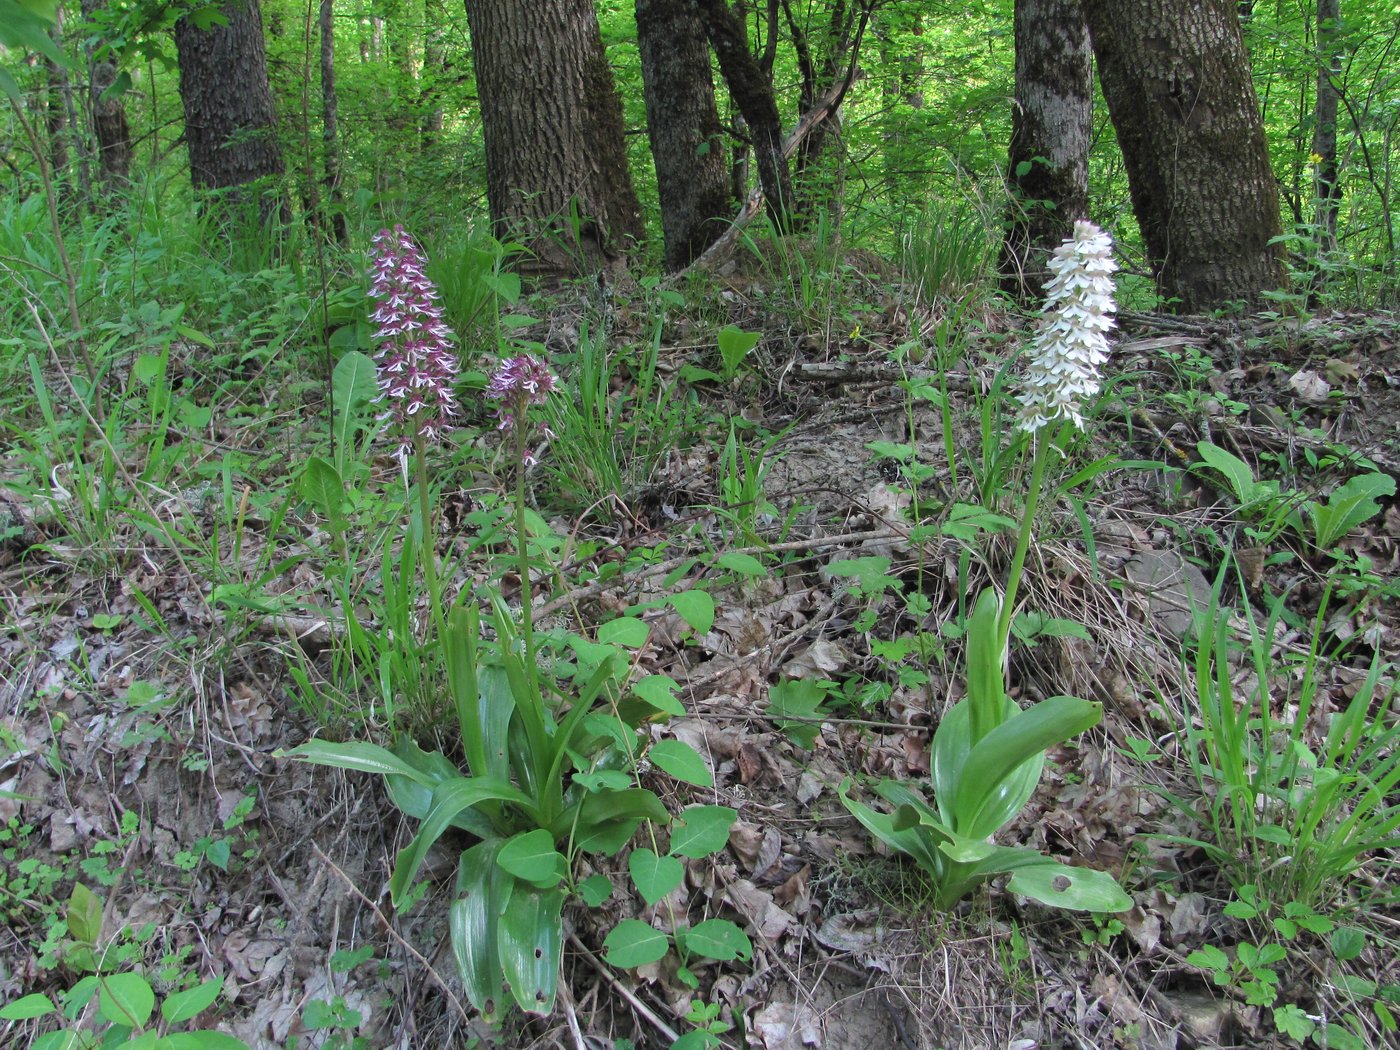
[[466, 0, 643, 276]]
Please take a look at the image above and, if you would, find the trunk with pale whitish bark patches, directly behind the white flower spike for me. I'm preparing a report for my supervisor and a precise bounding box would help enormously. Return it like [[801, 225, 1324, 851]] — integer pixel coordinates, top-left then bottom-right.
[[1001, 0, 1093, 301]]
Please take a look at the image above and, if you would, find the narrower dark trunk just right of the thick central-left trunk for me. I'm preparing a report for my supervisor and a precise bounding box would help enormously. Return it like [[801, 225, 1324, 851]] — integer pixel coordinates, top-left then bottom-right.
[[637, 0, 736, 270]]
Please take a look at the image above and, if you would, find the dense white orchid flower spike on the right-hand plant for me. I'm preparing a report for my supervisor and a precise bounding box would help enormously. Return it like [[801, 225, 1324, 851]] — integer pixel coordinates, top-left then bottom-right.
[[1018, 221, 1117, 434]]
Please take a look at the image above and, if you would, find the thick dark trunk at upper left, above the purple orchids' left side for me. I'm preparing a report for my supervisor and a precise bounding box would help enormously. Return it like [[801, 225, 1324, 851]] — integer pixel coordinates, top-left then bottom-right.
[[175, 0, 287, 224]]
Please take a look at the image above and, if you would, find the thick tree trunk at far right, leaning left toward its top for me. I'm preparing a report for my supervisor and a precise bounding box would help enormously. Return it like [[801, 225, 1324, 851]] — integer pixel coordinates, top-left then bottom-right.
[[1082, 0, 1284, 312]]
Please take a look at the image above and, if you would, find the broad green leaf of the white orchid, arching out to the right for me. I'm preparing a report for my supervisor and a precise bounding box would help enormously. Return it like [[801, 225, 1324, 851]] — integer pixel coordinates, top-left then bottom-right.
[[951, 696, 1103, 839]]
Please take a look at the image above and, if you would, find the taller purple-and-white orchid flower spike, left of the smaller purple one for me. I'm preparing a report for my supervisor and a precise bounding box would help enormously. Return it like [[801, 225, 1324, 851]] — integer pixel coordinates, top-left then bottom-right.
[[370, 225, 459, 463]]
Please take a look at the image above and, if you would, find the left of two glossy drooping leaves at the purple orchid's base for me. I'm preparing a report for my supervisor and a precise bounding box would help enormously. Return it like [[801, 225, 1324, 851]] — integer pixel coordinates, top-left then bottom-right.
[[448, 839, 515, 1025]]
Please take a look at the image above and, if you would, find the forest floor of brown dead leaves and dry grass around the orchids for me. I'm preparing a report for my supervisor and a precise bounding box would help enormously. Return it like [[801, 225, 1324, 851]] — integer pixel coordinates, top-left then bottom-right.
[[0, 268, 1400, 1050]]
